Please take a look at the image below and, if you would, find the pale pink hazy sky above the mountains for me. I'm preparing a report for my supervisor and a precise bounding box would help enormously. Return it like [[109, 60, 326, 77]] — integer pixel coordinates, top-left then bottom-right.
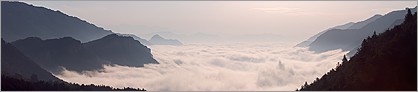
[[25, 1, 417, 41]]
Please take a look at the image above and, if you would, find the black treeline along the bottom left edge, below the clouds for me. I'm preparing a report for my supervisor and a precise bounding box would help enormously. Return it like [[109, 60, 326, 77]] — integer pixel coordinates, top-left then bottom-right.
[[1, 75, 146, 91]]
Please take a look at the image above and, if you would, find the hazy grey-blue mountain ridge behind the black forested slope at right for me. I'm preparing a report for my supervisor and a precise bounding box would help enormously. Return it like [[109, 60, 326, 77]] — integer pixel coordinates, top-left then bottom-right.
[[309, 7, 416, 52]]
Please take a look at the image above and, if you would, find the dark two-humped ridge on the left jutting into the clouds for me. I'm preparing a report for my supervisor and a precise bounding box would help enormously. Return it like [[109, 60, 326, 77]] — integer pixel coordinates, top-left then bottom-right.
[[12, 34, 158, 73]]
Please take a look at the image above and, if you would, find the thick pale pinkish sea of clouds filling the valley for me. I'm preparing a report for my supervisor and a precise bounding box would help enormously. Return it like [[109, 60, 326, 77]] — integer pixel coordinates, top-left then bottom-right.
[[55, 43, 347, 91]]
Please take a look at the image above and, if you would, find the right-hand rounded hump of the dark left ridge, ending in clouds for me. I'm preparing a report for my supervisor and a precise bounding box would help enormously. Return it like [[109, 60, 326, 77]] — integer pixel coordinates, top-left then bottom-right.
[[85, 34, 158, 67]]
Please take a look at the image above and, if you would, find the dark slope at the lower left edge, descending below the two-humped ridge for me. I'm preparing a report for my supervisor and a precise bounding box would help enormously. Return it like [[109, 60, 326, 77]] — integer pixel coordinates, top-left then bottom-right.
[[1, 39, 61, 83]]
